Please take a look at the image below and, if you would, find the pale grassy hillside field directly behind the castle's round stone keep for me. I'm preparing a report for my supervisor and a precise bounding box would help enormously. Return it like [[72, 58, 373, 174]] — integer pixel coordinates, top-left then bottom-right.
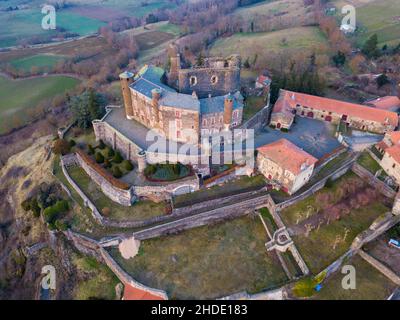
[[211, 27, 326, 61]]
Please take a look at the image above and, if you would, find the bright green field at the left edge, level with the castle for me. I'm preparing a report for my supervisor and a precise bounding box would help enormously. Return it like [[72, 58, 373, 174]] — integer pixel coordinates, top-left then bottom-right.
[[0, 76, 80, 133]]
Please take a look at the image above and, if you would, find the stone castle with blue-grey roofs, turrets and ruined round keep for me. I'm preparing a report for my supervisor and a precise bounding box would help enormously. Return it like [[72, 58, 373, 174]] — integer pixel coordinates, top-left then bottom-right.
[[120, 45, 243, 144]]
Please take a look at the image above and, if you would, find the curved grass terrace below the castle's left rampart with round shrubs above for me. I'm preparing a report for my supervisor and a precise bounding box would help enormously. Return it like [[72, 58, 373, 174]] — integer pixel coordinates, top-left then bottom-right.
[[68, 167, 165, 221]]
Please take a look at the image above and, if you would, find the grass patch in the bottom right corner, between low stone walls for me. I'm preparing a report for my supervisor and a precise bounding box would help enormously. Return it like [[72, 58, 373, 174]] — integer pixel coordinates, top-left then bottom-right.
[[313, 255, 396, 300]]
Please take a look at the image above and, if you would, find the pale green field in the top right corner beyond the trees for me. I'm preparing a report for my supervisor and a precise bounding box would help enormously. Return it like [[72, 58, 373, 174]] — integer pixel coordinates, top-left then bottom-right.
[[335, 0, 400, 46]]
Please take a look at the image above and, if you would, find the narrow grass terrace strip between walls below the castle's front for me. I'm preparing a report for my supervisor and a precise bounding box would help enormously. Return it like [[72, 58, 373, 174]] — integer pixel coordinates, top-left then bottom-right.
[[174, 175, 266, 207]]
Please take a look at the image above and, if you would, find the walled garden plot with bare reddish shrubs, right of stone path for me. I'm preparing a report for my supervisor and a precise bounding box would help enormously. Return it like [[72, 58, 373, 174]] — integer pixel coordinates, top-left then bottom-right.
[[281, 173, 390, 274]]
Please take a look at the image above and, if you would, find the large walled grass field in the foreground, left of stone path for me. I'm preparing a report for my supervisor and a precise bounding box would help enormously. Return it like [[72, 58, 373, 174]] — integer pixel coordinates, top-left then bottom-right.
[[112, 217, 287, 299]]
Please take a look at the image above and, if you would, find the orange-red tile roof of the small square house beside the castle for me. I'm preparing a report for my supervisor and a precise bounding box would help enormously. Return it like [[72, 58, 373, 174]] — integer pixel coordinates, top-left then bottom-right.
[[257, 139, 318, 175]]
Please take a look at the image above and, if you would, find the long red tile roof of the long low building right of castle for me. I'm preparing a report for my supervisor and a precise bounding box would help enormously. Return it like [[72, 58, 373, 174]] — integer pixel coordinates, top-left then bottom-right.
[[277, 90, 399, 127]]
